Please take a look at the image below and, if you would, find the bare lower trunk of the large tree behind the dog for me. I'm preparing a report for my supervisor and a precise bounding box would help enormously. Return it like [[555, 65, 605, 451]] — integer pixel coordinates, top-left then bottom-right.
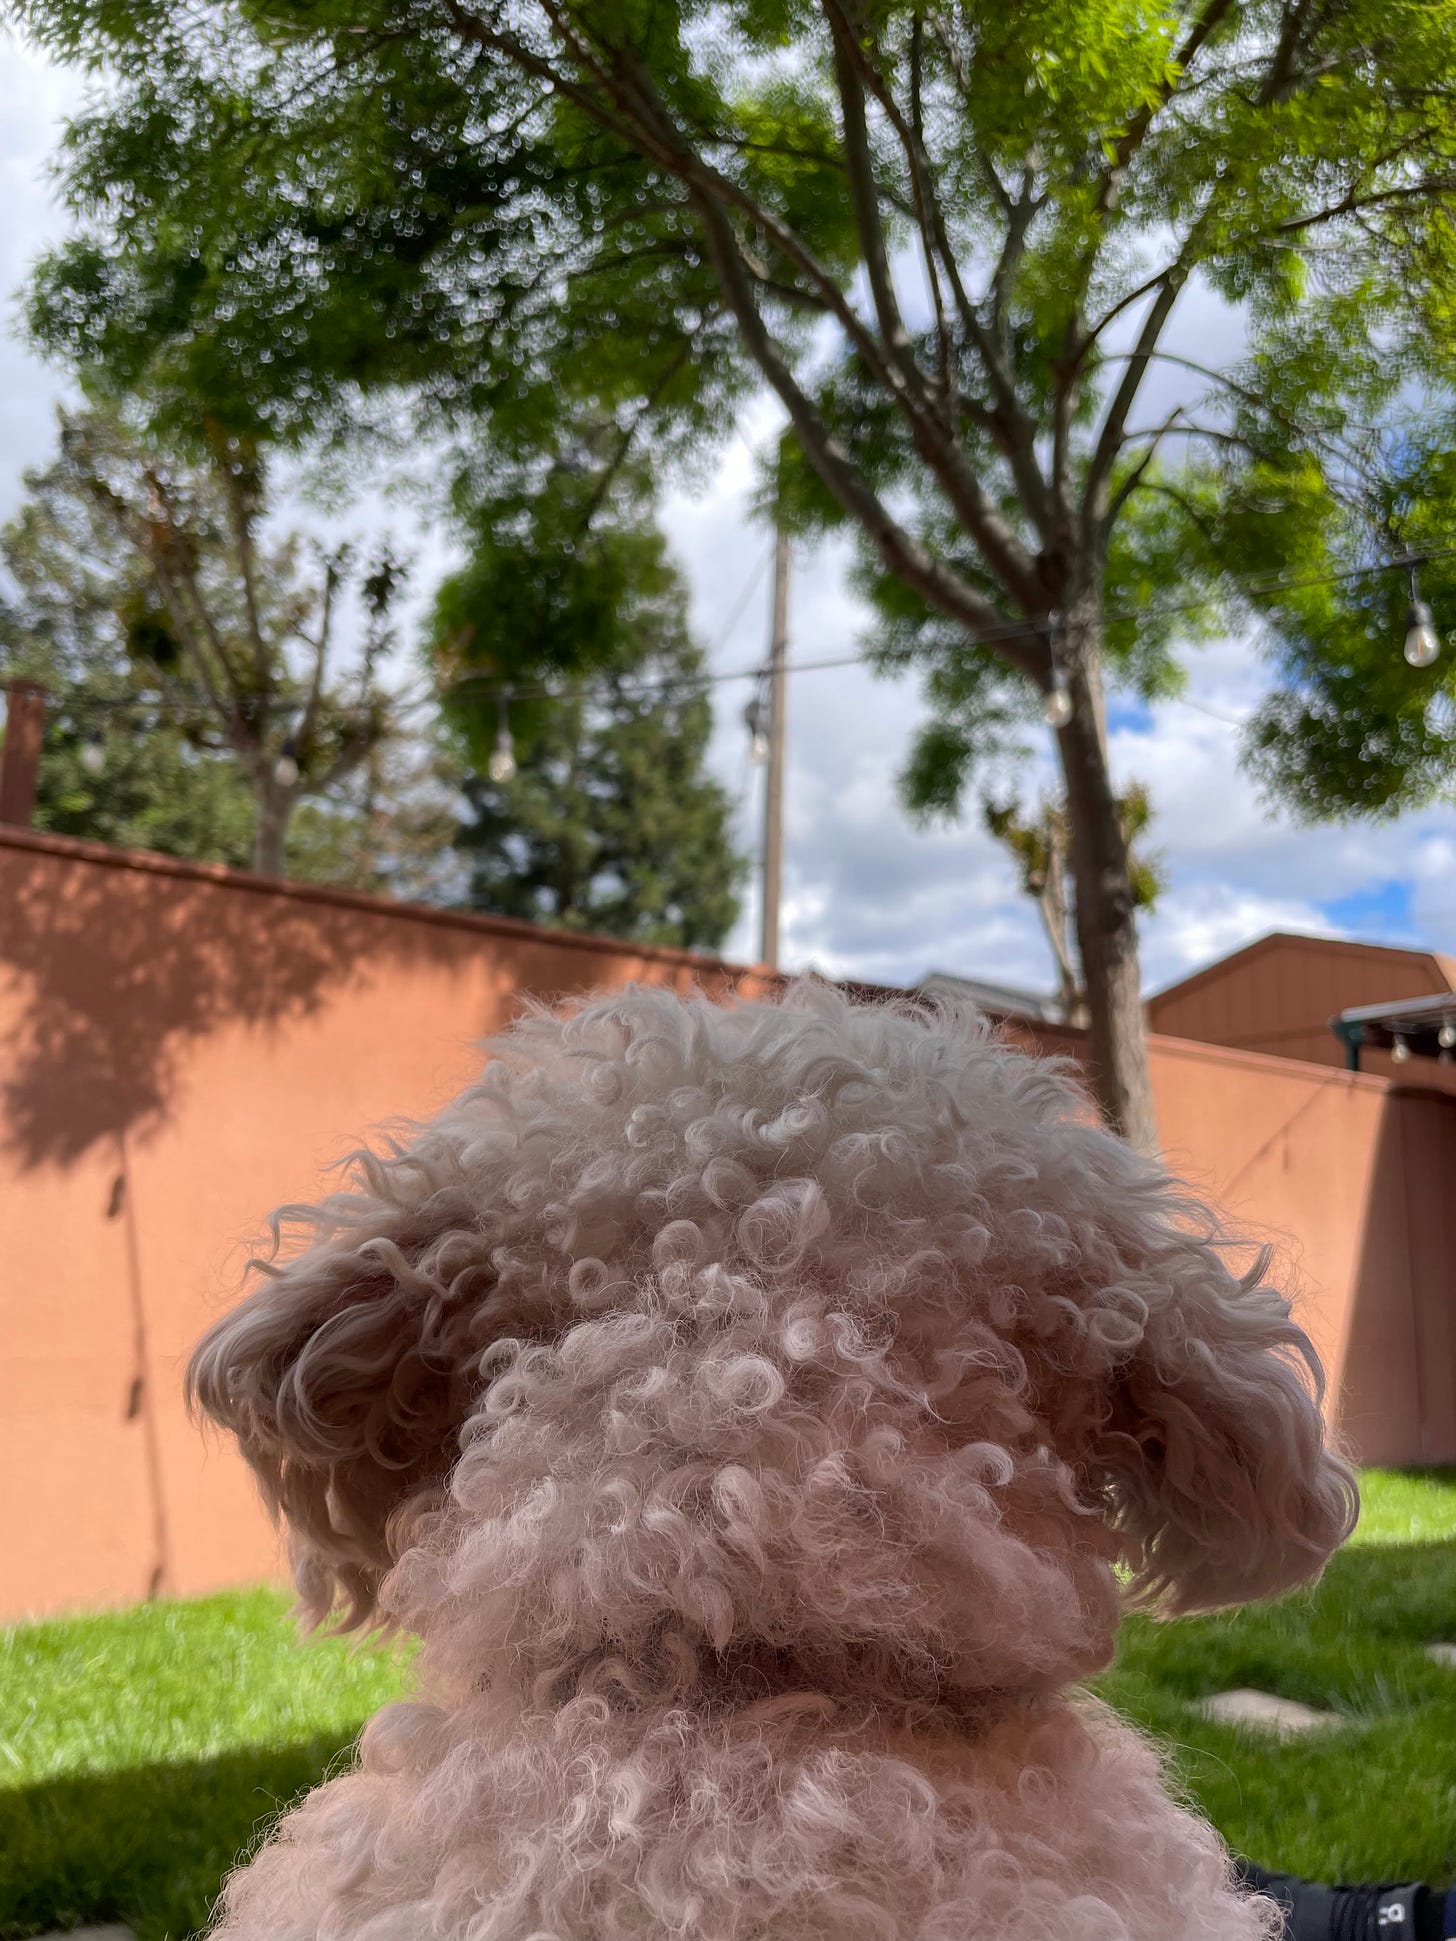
[[1056, 592, 1157, 1153]]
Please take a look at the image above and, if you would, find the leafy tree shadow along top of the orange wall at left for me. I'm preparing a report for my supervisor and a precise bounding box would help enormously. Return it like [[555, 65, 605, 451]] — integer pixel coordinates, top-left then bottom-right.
[[0, 839, 761, 1168]]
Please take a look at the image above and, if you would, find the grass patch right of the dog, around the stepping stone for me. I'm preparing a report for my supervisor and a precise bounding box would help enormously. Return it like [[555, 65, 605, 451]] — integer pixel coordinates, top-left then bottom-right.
[[1101, 1471, 1456, 1883]]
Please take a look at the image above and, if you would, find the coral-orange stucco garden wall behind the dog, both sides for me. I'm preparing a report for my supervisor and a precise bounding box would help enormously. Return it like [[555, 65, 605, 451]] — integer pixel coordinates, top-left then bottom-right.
[[0, 831, 1456, 1617]]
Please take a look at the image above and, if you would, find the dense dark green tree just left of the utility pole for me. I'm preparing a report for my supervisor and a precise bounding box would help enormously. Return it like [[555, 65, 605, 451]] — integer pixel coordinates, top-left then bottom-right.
[[435, 458, 744, 949]]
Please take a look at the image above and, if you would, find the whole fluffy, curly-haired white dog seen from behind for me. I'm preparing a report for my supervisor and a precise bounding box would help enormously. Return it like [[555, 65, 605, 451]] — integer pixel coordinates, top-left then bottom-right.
[[192, 986, 1355, 1941]]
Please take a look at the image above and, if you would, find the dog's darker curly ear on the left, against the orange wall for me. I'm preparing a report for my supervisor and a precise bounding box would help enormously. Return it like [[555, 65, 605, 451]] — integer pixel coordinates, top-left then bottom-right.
[[186, 1153, 489, 1628]]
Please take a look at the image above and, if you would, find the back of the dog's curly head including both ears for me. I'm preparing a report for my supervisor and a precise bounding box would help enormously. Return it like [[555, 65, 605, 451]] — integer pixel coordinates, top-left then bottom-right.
[[192, 986, 1353, 1696]]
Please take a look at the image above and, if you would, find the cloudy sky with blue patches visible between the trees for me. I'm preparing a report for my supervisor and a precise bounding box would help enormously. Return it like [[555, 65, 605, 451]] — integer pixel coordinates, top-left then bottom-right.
[[0, 29, 1456, 988]]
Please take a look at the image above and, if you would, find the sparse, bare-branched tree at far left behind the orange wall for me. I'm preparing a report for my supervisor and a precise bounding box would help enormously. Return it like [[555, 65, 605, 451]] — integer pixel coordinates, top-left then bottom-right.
[[0, 411, 400, 875]]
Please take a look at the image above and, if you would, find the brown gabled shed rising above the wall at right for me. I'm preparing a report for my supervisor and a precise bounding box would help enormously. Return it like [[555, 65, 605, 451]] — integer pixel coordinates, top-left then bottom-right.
[[1147, 930, 1456, 1091]]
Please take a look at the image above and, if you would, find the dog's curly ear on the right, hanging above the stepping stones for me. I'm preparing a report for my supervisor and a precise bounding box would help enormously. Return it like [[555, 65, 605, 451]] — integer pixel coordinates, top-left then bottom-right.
[[1093, 1156, 1359, 1615]]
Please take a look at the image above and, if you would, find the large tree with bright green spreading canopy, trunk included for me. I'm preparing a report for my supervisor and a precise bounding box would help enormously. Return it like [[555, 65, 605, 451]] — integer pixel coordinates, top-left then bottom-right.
[[17, 0, 1456, 1141]]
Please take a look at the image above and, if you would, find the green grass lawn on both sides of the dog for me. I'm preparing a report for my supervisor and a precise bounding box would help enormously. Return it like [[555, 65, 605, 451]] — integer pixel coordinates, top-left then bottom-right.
[[0, 1473, 1456, 1941]]
